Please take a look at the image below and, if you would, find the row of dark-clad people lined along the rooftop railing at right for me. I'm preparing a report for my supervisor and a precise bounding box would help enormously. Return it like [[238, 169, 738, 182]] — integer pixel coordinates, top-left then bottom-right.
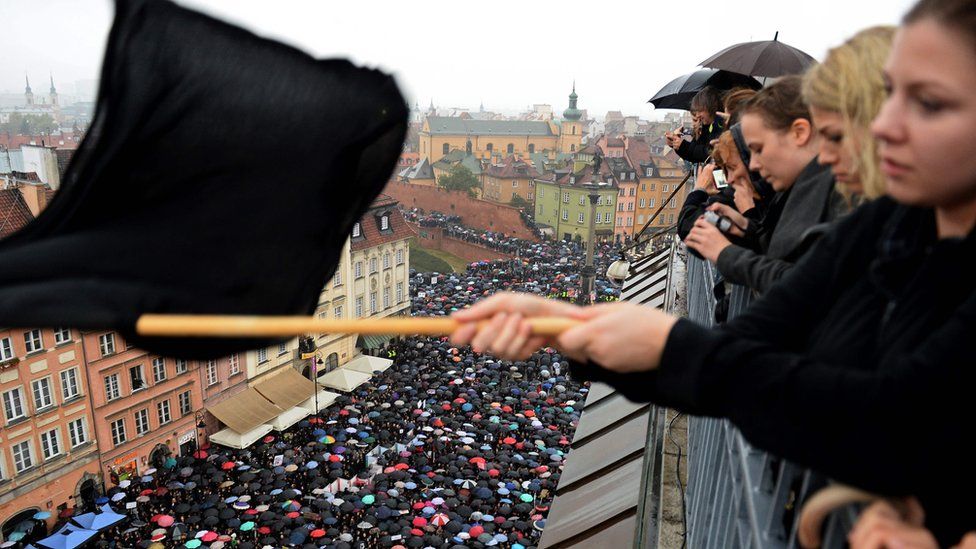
[[451, 0, 976, 548]]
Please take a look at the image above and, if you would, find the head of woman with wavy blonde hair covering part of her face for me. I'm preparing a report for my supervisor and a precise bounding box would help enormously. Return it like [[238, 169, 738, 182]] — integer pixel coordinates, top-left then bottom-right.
[[803, 26, 896, 199]]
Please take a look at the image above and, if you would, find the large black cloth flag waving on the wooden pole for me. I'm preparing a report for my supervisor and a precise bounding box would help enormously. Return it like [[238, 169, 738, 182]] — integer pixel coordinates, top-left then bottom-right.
[[0, 0, 407, 359]]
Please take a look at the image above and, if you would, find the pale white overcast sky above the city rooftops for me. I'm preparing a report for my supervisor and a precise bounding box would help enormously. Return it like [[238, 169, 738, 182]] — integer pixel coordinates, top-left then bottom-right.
[[0, 0, 912, 117]]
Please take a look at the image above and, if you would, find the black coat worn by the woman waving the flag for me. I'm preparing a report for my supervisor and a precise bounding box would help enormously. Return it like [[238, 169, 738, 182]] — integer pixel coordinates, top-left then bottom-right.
[[570, 198, 976, 544]]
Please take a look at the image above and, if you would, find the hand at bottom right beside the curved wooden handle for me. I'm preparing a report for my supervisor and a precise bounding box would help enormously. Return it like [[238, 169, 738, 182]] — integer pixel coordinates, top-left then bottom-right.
[[847, 499, 939, 549]]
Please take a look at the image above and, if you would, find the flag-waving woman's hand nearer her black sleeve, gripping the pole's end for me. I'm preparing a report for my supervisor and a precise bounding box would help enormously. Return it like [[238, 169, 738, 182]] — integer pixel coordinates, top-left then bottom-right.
[[556, 301, 678, 373]]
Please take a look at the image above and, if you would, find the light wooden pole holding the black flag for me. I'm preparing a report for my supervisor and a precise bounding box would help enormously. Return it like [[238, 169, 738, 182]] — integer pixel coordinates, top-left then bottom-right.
[[136, 314, 582, 337]]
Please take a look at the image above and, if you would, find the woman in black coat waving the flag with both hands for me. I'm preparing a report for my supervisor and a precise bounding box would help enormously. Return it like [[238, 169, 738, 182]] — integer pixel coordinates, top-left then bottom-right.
[[452, 0, 976, 544]]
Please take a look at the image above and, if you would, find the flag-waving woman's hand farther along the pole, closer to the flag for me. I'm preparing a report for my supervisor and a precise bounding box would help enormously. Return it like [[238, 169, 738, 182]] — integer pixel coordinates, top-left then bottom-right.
[[450, 292, 583, 360]]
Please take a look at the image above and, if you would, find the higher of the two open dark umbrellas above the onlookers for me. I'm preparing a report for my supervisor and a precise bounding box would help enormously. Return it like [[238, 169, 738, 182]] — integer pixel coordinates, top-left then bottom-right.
[[701, 32, 817, 78]]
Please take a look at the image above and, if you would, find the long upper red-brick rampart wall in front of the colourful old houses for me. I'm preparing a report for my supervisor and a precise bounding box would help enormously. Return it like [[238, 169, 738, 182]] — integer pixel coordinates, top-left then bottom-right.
[[383, 181, 538, 241]]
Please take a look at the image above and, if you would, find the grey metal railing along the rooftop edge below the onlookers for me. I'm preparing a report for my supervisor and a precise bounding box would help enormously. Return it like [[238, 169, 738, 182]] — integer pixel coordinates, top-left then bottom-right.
[[685, 254, 856, 549]]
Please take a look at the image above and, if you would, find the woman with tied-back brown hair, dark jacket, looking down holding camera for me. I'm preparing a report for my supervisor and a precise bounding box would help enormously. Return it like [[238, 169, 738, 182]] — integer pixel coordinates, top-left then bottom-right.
[[685, 76, 849, 293]]
